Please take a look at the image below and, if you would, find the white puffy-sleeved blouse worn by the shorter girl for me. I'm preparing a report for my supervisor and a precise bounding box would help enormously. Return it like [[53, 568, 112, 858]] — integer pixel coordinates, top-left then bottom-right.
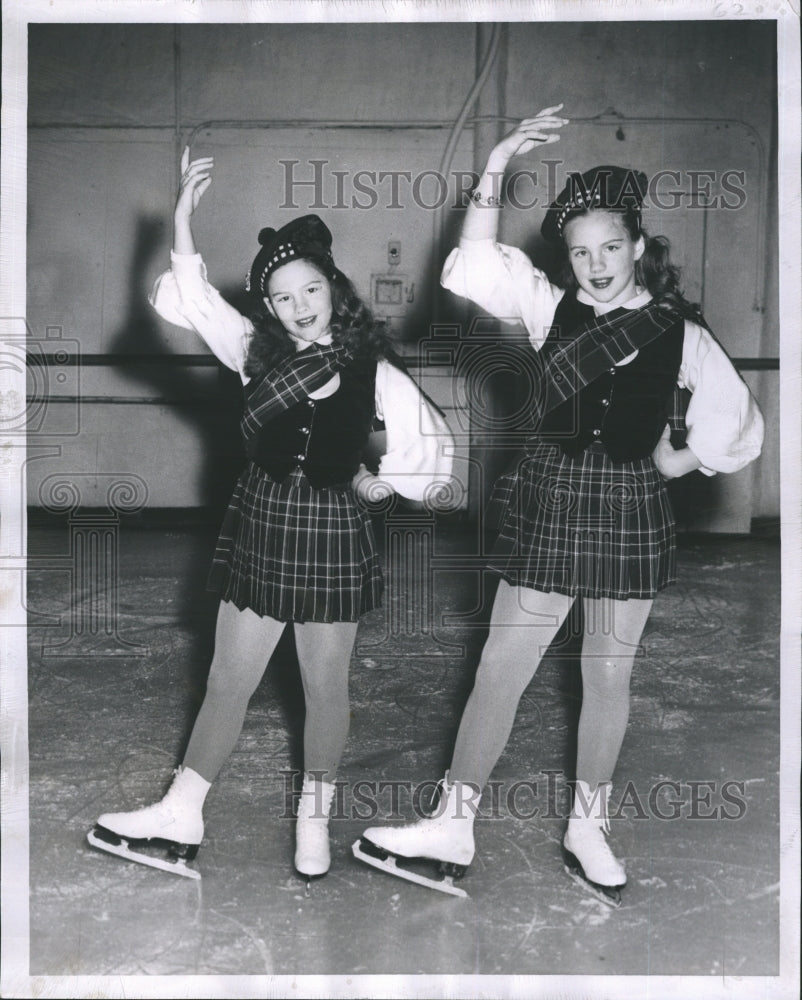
[[149, 252, 454, 501]]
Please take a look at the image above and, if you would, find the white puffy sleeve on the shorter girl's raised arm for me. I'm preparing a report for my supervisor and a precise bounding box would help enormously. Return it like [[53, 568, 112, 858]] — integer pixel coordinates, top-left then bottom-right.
[[149, 251, 253, 382]]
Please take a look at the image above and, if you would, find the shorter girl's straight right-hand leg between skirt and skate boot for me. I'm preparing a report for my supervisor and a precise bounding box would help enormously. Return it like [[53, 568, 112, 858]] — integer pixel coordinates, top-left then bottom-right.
[[295, 622, 357, 782]]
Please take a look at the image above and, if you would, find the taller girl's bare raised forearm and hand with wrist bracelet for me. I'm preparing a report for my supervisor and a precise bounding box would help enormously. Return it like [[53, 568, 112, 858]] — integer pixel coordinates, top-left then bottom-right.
[[461, 104, 568, 240]]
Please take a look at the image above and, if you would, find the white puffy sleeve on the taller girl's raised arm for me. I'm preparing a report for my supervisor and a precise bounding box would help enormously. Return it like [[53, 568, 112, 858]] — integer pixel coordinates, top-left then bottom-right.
[[440, 239, 563, 350]]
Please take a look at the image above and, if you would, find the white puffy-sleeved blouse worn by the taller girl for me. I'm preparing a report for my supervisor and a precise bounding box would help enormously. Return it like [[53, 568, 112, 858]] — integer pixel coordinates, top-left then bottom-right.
[[440, 239, 763, 476]]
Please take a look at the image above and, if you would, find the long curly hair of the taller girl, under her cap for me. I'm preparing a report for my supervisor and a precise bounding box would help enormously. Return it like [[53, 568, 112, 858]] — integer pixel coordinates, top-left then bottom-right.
[[558, 208, 709, 329]]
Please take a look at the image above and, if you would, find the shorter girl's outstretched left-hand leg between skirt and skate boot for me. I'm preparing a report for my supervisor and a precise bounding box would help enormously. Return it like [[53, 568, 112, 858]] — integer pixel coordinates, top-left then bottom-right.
[[184, 601, 286, 781]]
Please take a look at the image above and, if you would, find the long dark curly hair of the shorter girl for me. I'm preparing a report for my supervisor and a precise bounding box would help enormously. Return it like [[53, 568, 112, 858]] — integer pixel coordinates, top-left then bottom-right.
[[245, 254, 392, 378]]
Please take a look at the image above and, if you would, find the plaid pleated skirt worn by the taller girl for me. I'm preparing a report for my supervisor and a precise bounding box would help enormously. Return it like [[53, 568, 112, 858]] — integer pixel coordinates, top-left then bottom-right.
[[489, 443, 676, 600]]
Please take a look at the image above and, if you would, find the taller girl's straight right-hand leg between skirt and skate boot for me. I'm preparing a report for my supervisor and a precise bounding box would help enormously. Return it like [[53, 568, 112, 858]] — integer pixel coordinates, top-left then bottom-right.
[[576, 598, 652, 788]]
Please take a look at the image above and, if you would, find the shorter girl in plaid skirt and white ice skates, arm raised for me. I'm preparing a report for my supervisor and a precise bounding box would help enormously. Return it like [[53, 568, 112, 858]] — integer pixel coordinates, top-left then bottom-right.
[[89, 150, 452, 878]]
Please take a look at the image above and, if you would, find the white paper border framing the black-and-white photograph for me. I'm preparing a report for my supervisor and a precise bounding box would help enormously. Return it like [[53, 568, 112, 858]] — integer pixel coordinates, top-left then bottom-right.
[[0, 0, 802, 1000]]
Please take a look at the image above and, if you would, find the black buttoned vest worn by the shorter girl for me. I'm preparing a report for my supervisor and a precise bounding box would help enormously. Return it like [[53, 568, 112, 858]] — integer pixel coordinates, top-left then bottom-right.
[[245, 359, 376, 489]]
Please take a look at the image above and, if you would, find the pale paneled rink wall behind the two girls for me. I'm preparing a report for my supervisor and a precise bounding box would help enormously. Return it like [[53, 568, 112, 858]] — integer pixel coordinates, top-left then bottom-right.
[[27, 22, 779, 530]]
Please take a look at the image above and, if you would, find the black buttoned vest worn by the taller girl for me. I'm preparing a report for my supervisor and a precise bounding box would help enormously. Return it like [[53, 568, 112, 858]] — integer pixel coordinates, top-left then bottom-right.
[[537, 293, 685, 462]]
